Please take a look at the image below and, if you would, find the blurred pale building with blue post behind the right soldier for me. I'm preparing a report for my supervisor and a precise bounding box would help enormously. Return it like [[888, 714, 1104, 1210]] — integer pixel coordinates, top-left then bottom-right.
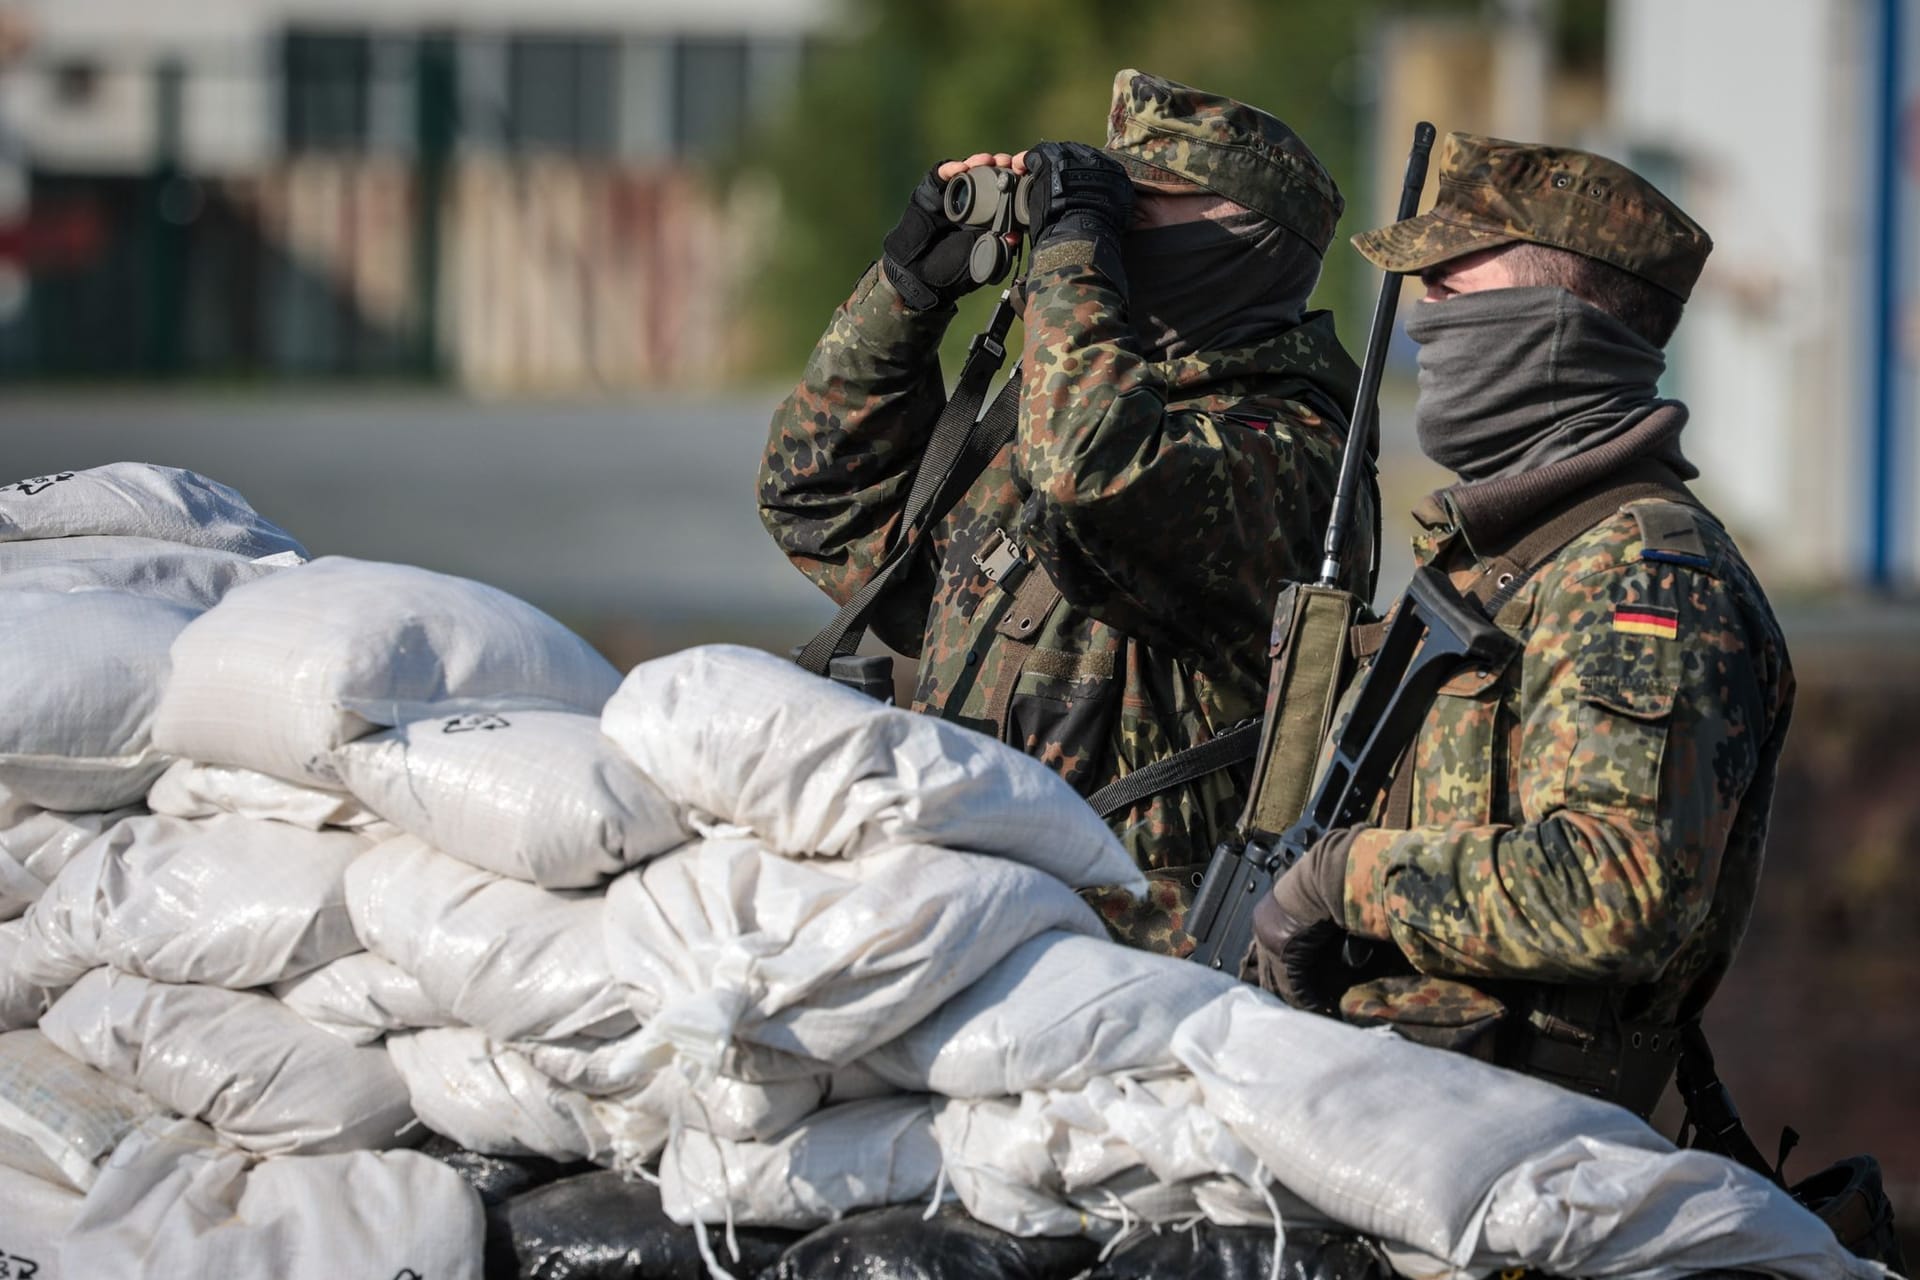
[[1373, 0, 1920, 587]]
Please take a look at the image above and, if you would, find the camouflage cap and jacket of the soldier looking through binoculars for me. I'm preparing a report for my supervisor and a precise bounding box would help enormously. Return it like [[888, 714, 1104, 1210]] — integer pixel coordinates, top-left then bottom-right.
[[760, 71, 1373, 954]]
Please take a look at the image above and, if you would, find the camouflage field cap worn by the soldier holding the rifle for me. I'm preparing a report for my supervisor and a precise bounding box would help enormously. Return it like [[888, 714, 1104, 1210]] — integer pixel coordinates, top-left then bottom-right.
[[1354, 132, 1713, 301]]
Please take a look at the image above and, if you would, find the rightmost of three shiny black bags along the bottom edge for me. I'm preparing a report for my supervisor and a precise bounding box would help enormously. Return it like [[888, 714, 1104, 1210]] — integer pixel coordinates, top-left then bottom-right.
[[1089, 1222, 1394, 1280]]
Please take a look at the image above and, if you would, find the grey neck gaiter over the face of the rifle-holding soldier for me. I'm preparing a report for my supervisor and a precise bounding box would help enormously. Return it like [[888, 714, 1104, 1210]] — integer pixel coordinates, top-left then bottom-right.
[[1405, 288, 1684, 482]]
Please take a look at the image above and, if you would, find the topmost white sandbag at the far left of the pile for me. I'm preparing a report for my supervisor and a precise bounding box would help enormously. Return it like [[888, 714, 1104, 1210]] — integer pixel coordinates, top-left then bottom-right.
[[0, 462, 307, 558]]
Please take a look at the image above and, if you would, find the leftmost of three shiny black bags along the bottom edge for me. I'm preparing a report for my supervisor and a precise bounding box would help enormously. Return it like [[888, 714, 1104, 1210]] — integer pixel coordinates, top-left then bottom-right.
[[486, 1169, 801, 1280]]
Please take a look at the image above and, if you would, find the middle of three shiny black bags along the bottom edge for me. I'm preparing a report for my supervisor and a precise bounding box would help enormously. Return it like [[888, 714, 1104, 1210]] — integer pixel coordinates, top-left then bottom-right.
[[762, 1205, 1100, 1280]]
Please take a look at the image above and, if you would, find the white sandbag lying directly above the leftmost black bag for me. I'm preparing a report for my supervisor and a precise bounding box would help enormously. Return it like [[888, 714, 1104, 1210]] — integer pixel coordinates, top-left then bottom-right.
[[386, 1027, 612, 1161]]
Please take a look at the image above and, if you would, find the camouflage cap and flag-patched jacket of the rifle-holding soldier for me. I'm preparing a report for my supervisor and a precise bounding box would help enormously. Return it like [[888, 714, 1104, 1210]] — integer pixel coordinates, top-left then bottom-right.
[[1313, 134, 1793, 1105]]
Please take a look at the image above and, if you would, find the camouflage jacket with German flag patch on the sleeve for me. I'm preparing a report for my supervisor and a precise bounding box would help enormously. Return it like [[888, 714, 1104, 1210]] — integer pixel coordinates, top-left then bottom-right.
[[1342, 503, 1793, 1042]]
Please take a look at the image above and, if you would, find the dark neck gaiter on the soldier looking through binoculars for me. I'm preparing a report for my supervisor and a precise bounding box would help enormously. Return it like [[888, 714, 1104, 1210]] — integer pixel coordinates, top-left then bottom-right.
[[1119, 211, 1321, 361]]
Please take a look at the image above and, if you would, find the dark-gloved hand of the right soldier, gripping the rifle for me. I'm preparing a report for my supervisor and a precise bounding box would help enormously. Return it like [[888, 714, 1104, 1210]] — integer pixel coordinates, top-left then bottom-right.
[[1254, 829, 1359, 1013]]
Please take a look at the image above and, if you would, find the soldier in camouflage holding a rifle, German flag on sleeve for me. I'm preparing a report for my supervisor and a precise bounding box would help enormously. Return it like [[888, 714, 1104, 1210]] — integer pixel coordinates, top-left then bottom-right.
[[1254, 134, 1793, 1115]]
